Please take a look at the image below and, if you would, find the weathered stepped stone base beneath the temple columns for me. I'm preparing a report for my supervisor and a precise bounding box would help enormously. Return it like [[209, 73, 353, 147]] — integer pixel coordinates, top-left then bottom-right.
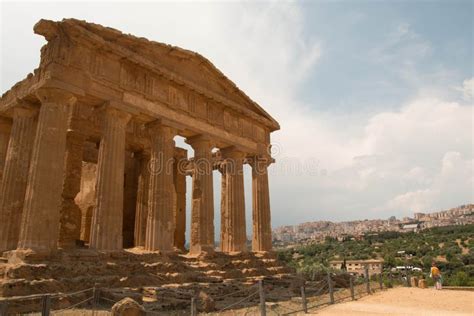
[[0, 248, 292, 297]]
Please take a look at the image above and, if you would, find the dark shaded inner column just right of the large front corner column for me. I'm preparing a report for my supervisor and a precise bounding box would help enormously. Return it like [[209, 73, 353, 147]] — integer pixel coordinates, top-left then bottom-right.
[[58, 111, 86, 248]]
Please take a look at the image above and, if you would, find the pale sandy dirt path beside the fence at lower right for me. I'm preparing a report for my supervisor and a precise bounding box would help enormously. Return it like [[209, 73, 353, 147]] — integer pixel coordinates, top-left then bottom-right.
[[311, 288, 474, 316]]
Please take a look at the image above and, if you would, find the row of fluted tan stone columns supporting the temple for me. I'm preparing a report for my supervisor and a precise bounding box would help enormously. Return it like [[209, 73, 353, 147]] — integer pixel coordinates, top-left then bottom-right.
[[0, 89, 271, 253]]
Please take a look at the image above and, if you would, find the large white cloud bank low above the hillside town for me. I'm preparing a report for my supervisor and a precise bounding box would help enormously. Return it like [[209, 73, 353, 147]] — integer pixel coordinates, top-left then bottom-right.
[[272, 91, 474, 222]]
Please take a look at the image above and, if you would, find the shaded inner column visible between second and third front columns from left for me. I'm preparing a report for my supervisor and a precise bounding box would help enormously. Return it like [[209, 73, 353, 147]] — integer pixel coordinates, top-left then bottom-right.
[[134, 153, 150, 247]]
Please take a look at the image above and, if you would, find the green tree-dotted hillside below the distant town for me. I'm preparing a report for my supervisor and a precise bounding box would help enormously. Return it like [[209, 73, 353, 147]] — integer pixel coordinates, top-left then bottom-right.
[[278, 224, 474, 286]]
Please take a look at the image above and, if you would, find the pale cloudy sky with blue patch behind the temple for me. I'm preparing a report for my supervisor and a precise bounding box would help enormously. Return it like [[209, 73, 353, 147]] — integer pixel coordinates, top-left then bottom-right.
[[0, 0, 474, 236]]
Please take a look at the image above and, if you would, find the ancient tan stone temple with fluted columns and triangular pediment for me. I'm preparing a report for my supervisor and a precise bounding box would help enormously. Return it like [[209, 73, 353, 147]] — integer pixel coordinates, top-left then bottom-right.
[[0, 19, 279, 258]]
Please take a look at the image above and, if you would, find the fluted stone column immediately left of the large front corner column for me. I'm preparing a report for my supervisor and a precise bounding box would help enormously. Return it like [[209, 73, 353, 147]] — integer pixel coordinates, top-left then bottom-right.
[[0, 107, 37, 253]]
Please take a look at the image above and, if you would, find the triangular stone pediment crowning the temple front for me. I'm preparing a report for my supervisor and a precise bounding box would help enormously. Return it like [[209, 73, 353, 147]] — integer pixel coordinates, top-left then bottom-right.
[[35, 19, 280, 131]]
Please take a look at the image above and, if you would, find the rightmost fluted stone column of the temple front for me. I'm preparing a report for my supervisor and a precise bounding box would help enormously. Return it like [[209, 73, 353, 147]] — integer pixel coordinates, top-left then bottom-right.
[[252, 156, 272, 251]]
